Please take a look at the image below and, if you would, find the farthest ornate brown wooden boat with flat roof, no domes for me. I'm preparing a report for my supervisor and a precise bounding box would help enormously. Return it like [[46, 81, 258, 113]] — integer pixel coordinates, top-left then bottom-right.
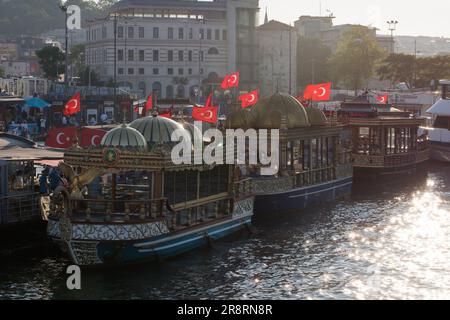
[[339, 100, 429, 179]]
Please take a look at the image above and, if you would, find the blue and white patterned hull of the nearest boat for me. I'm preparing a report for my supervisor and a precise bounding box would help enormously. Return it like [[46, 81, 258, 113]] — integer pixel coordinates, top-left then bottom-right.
[[47, 198, 253, 266]]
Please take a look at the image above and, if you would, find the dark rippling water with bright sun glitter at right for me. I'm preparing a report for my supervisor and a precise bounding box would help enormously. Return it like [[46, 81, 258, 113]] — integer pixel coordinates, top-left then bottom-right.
[[0, 164, 450, 299]]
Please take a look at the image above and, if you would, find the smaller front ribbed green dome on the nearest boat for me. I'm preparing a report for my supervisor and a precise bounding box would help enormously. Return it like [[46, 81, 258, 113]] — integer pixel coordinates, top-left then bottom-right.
[[100, 124, 147, 149]]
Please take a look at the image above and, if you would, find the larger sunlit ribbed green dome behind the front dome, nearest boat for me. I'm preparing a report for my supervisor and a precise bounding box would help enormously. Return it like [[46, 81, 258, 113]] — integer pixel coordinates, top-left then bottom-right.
[[130, 115, 189, 145]]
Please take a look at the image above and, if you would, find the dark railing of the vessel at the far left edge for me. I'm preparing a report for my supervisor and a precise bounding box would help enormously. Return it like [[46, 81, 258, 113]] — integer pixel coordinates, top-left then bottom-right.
[[0, 193, 42, 224]]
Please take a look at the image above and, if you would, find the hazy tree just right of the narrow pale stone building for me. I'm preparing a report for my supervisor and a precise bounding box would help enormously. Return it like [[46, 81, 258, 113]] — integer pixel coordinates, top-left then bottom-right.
[[297, 37, 331, 87]]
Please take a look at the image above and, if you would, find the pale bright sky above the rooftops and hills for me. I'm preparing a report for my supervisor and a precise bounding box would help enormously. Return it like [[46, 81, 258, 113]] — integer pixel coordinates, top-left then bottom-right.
[[259, 0, 450, 37]]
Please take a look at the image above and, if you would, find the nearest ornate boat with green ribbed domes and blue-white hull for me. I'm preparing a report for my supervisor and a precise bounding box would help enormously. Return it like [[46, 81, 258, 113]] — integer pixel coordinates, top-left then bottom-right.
[[47, 114, 254, 266]]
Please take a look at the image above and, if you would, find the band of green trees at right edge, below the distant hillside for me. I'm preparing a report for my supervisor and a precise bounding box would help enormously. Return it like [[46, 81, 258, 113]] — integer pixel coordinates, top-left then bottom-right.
[[378, 54, 450, 88]]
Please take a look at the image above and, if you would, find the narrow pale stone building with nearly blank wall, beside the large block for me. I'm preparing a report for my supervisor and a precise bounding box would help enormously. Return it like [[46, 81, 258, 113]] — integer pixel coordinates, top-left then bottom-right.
[[258, 20, 298, 96]]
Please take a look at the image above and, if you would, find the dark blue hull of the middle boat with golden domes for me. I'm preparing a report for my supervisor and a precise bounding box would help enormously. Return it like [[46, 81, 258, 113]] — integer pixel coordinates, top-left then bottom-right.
[[255, 177, 353, 215]]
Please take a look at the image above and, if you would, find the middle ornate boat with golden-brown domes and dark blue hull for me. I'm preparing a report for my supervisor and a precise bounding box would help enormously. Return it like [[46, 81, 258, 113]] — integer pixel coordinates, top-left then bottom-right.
[[225, 93, 353, 215]]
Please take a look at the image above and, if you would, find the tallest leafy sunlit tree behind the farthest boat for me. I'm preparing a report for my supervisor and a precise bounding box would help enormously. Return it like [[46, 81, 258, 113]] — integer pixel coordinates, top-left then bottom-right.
[[330, 26, 383, 93]]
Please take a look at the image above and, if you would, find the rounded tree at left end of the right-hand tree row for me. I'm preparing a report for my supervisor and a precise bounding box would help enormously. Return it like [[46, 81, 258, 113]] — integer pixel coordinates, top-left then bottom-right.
[[378, 54, 416, 88]]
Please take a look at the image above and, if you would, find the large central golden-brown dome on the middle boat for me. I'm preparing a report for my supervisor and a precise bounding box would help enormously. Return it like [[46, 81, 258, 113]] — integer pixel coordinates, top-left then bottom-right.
[[251, 93, 310, 129]]
